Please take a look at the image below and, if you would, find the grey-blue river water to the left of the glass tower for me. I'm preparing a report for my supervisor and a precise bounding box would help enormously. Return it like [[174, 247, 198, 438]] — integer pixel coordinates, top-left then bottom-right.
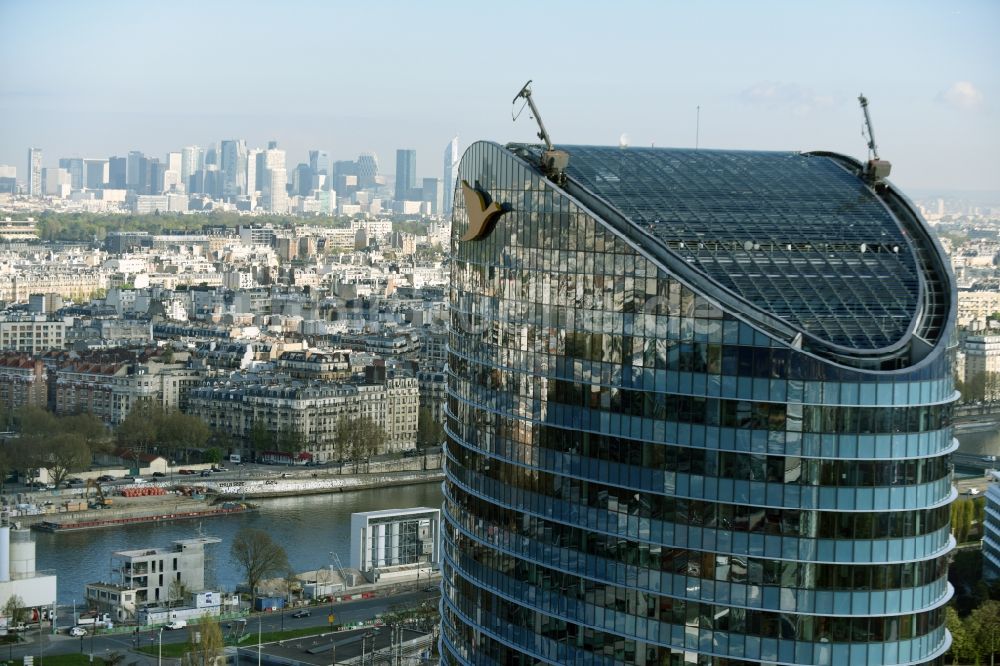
[[34, 482, 442, 605]]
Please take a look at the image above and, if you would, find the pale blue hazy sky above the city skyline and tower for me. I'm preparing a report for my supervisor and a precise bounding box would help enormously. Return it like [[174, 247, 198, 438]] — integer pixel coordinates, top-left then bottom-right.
[[0, 0, 1000, 190]]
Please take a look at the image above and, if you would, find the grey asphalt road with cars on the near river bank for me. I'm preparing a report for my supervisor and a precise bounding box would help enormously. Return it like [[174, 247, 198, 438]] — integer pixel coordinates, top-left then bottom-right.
[[6, 588, 440, 666]]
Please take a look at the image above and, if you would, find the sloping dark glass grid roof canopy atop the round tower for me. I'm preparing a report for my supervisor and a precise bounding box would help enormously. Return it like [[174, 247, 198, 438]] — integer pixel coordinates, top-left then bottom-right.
[[559, 146, 920, 350]]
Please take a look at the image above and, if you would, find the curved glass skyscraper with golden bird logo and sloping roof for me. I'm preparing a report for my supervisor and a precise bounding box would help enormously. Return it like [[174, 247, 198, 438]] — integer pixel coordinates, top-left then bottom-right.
[[441, 142, 957, 666]]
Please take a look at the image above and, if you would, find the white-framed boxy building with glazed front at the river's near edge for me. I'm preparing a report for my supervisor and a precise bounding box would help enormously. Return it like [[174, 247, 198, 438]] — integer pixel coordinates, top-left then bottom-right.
[[351, 507, 441, 578]]
